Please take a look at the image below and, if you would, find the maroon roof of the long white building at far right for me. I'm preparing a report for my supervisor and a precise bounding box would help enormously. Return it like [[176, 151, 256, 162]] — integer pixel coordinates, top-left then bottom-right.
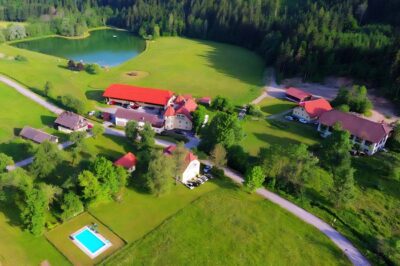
[[319, 110, 392, 143]]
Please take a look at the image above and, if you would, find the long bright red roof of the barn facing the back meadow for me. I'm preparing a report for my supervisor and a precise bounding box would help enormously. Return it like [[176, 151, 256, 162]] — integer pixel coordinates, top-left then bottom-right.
[[103, 84, 174, 106]]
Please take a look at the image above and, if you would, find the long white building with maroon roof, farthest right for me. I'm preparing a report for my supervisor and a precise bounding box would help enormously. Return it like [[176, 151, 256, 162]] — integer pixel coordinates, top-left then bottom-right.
[[318, 110, 393, 155]]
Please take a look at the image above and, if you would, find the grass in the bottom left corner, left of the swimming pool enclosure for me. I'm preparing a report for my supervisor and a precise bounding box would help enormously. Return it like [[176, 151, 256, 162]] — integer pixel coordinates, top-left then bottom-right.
[[0, 200, 69, 266]]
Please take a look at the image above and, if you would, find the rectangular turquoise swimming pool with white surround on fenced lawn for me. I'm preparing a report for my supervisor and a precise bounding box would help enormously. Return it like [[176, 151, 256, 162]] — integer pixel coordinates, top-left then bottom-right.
[[72, 226, 111, 258]]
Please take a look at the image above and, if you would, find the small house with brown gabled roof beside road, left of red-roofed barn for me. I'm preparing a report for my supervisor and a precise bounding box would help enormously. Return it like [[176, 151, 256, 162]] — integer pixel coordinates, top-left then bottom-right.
[[54, 111, 89, 133]]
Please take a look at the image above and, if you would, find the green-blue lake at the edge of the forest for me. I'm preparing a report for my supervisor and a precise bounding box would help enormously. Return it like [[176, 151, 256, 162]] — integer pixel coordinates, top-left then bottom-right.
[[13, 30, 146, 67]]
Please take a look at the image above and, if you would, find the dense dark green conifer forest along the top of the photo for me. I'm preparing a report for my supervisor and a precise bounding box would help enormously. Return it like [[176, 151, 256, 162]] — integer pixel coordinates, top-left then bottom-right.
[[0, 0, 400, 99]]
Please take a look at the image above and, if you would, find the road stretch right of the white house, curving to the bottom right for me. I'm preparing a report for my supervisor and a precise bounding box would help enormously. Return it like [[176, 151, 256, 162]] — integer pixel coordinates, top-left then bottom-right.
[[202, 161, 371, 266]]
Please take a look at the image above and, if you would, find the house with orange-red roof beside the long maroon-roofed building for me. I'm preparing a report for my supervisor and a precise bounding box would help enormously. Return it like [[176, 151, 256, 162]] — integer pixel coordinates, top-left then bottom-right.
[[292, 98, 332, 122]]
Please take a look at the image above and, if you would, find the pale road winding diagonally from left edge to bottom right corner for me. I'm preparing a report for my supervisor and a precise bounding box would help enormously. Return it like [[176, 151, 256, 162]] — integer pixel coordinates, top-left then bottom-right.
[[0, 75, 370, 266]]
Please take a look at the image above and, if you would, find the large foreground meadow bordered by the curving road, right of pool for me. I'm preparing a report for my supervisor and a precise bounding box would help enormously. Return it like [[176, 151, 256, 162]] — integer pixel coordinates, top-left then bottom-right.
[[103, 188, 350, 265]]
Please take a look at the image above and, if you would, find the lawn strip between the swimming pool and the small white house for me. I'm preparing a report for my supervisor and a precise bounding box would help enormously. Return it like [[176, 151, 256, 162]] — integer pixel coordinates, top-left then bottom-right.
[[90, 182, 218, 242]]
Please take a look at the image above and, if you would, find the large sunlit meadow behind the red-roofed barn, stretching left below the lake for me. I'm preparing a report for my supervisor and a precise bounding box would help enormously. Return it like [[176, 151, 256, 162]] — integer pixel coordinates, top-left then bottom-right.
[[0, 37, 264, 109]]
